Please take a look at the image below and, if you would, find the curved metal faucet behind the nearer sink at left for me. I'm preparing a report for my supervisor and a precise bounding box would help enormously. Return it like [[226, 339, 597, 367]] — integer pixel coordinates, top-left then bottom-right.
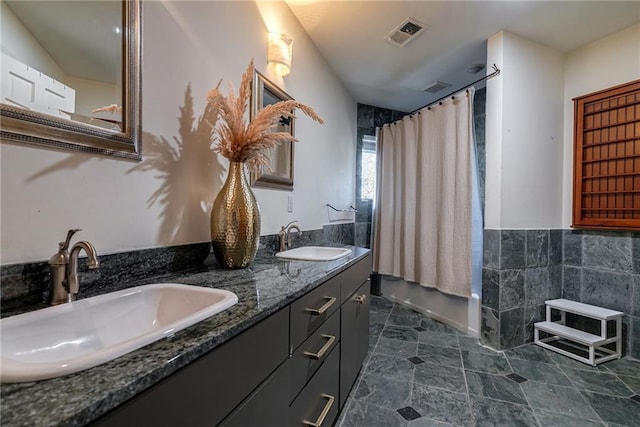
[[49, 229, 99, 305]]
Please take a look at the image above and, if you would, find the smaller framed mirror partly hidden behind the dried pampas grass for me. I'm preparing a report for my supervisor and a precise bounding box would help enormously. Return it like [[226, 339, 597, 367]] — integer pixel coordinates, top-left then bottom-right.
[[249, 71, 295, 191]]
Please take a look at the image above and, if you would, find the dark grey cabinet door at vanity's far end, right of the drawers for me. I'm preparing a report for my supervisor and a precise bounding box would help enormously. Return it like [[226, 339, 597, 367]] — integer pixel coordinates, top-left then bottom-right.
[[340, 280, 371, 408]]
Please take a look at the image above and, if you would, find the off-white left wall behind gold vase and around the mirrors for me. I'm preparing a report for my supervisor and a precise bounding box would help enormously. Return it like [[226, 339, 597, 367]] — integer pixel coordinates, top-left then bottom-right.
[[0, 1, 356, 264]]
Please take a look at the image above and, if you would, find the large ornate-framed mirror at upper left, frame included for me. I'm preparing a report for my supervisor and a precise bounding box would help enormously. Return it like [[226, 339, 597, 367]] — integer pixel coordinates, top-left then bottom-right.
[[0, 0, 141, 160]]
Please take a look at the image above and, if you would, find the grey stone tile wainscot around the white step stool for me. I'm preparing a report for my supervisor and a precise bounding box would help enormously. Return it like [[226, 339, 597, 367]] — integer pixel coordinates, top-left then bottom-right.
[[481, 230, 640, 359]]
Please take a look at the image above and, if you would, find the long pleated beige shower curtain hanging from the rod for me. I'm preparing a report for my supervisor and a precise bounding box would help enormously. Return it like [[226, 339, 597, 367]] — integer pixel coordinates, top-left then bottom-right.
[[373, 88, 473, 298]]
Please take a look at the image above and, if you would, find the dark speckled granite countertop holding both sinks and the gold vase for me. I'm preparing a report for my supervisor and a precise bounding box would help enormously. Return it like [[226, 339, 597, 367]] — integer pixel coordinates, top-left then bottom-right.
[[0, 247, 369, 427]]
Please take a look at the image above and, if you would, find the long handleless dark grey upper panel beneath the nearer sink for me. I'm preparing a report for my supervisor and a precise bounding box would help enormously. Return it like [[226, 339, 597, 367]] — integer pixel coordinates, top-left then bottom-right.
[[93, 308, 289, 427]]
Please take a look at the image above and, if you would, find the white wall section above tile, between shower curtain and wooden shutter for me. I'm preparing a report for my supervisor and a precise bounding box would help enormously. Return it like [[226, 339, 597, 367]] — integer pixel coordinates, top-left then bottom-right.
[[485, 32, 564, 229]]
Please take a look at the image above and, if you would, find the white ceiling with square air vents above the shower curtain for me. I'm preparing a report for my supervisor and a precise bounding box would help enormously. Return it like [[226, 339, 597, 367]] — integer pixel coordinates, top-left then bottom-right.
[[287, 0, 640, 112]]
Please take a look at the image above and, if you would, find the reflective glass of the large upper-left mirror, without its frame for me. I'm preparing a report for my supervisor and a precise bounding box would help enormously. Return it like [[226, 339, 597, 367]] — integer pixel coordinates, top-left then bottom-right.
[[0, 0, 124, 132]]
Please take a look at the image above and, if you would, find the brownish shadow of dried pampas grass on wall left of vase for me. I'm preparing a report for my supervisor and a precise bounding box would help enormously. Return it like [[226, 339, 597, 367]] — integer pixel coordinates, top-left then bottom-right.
[[127, 84, 225, 245]]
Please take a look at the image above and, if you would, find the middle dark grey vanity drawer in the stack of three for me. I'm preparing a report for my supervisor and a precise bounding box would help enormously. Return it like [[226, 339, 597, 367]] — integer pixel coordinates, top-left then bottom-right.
[[287, 310, 340, 402]]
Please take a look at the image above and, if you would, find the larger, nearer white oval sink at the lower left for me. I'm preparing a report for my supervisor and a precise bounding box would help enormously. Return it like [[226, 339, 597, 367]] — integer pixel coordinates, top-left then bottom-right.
[[0, 283, 238, 383]]
